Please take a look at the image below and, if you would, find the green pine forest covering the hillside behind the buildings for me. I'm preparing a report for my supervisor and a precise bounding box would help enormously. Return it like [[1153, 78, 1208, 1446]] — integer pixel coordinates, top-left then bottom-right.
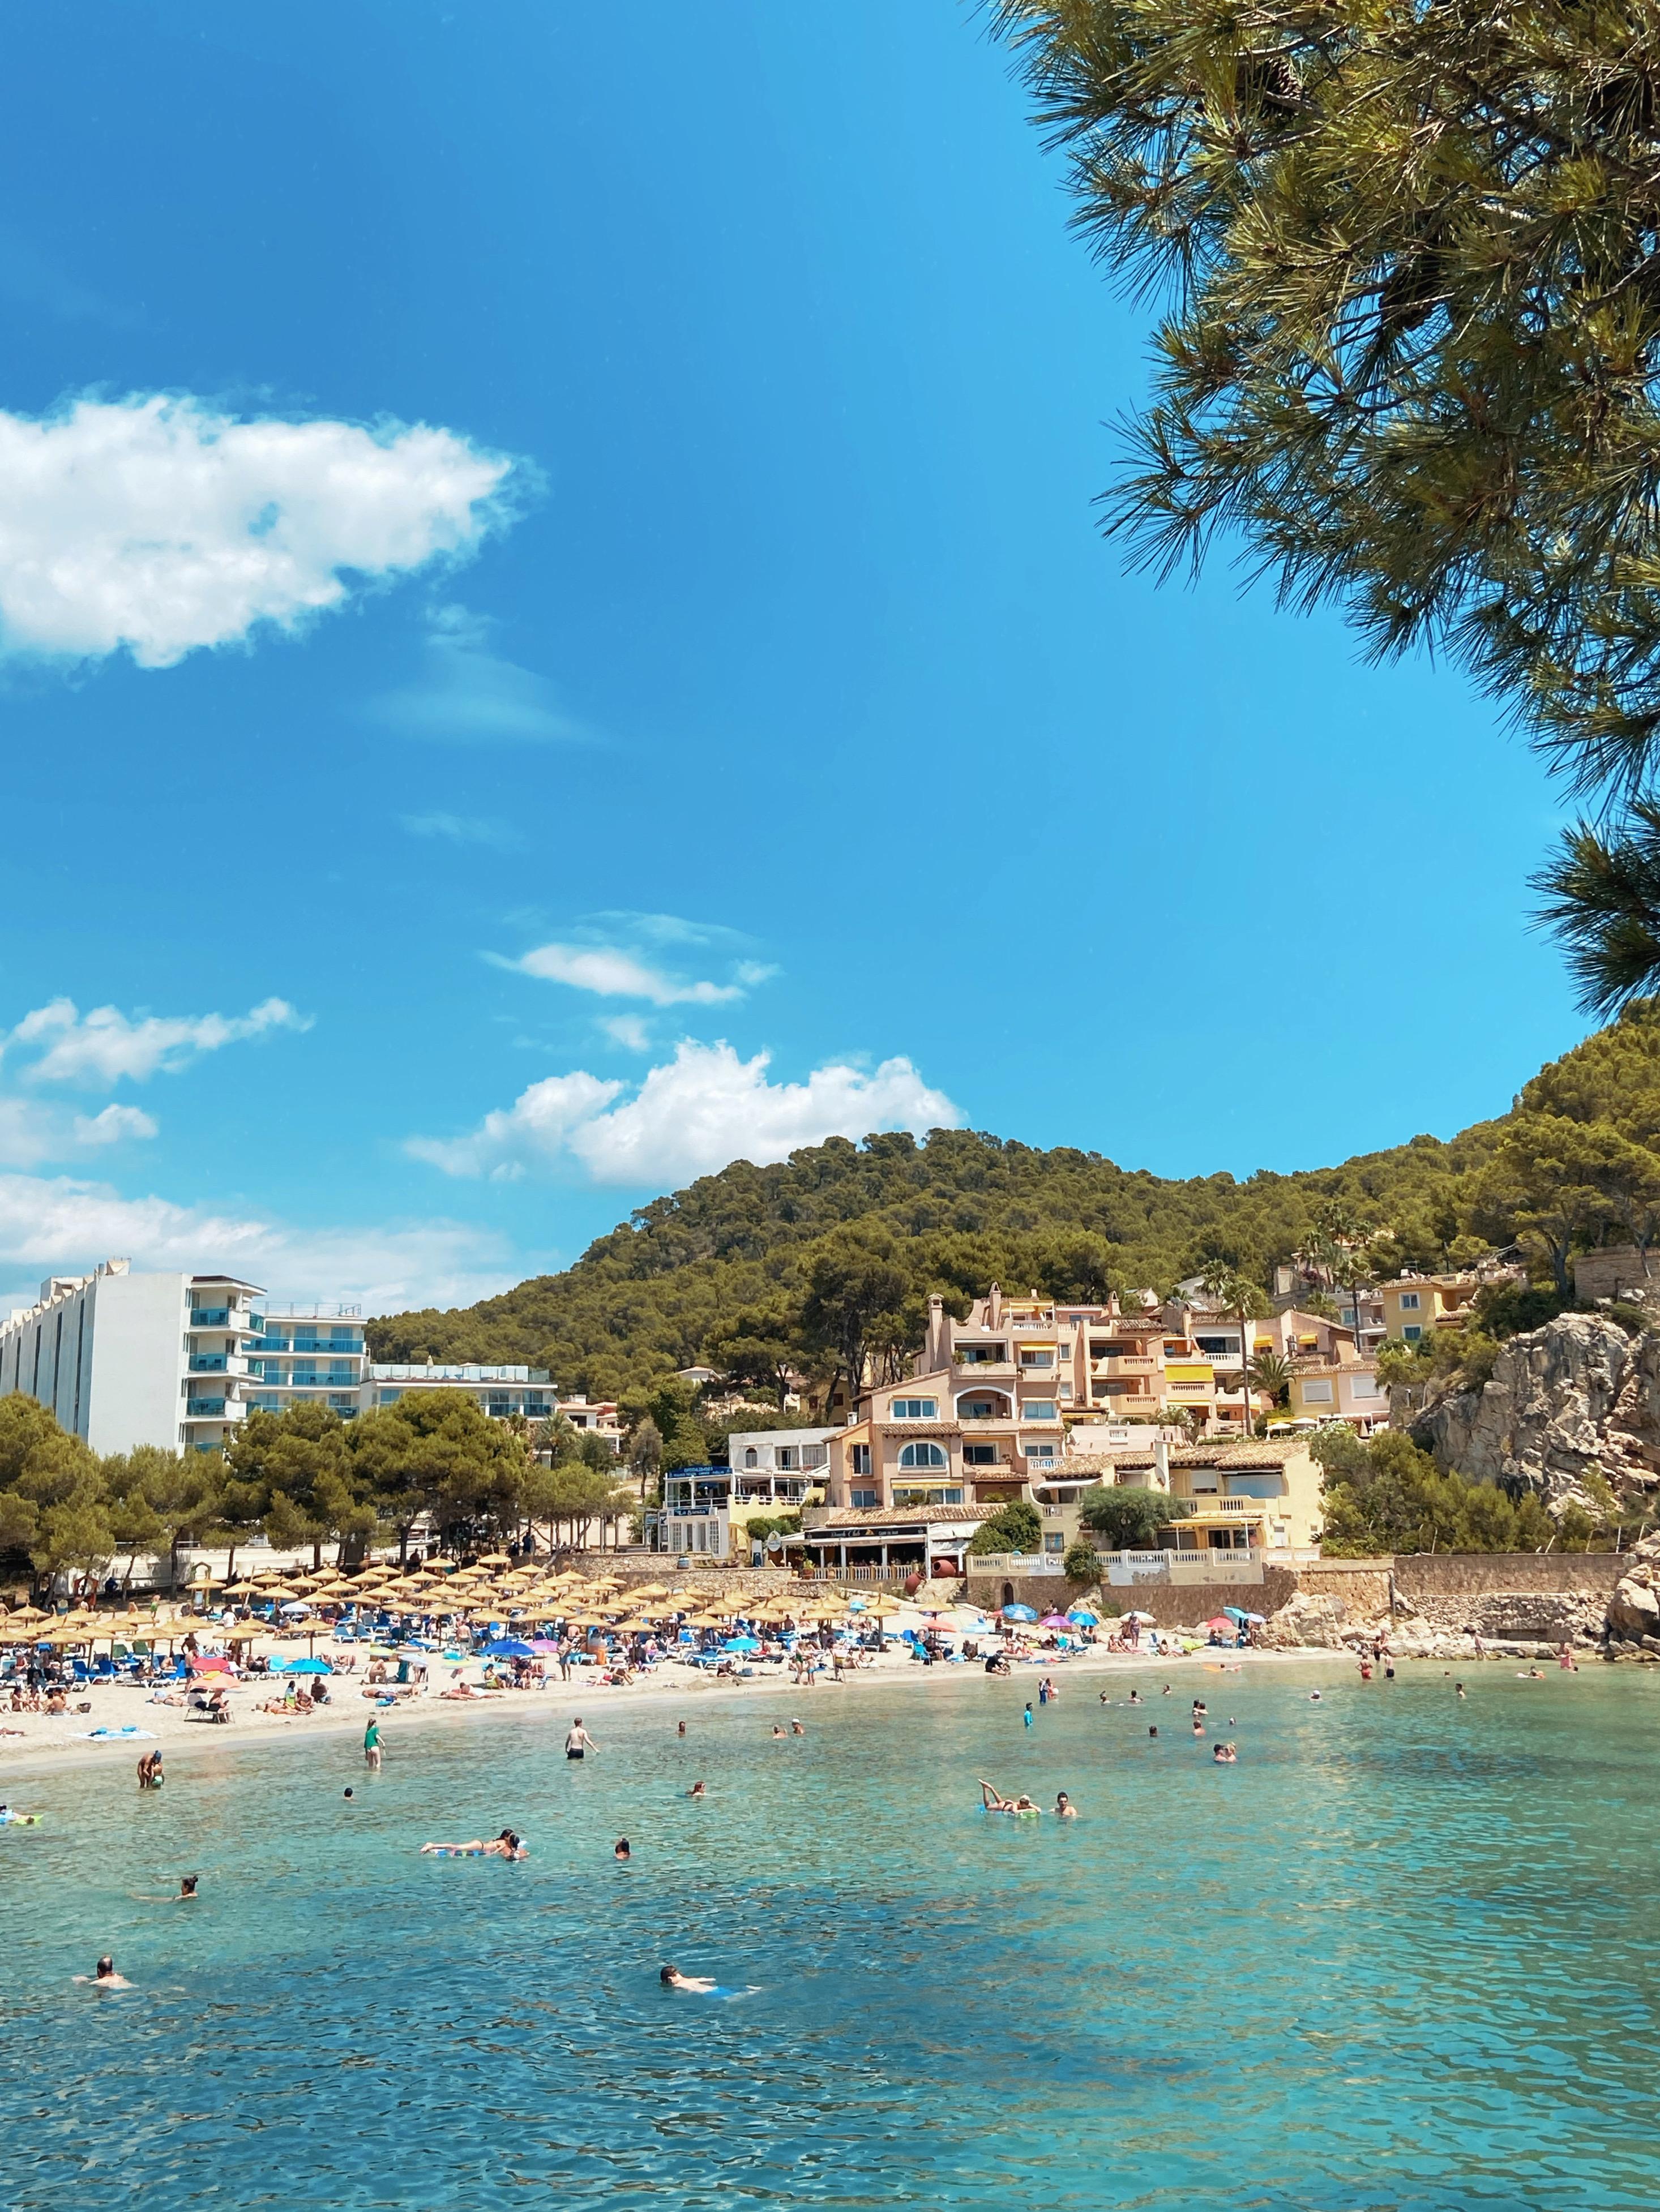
[[370, 1000, 1660, 1400]]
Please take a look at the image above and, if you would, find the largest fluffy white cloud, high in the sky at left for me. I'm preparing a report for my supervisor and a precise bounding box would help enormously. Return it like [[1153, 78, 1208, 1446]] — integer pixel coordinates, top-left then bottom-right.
[[0, 394, 514, 668]]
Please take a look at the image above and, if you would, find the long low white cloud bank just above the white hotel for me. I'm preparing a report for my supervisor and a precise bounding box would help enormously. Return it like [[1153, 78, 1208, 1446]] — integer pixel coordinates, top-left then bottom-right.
[[0, 1174, 523, 1314]]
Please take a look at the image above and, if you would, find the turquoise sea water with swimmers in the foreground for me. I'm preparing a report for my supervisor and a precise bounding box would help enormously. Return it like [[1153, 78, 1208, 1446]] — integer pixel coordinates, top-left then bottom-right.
[[0, 1666, 1660, 2212]]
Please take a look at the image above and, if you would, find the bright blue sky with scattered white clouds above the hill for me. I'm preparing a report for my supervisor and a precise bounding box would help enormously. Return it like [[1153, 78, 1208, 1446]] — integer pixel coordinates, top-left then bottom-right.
[[0, 0, 1582, 1308]]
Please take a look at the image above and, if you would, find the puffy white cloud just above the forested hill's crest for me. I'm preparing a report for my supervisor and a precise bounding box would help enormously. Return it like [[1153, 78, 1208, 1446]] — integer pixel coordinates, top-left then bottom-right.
[[407, 1040, 963, 1188]]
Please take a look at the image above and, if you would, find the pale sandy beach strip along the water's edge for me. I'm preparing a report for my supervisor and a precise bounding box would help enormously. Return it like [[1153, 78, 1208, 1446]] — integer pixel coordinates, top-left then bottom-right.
[[0, 1644, 1355, 1785]]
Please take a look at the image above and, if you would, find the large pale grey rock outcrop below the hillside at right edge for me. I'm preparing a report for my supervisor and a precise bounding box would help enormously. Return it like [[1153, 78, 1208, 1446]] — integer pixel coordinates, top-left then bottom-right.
[[1410, 1314, 1660, 1504]]
